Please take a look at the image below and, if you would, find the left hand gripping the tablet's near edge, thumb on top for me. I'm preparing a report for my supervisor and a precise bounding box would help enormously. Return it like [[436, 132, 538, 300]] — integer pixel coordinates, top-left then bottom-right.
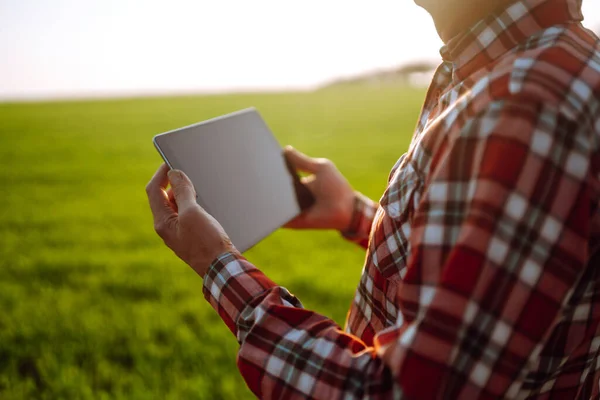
[[146, 164, 237, 277]]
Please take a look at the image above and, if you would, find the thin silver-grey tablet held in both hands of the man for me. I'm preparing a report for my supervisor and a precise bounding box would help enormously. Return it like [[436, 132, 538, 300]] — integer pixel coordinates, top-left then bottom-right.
[[153, 108, 314, 252]]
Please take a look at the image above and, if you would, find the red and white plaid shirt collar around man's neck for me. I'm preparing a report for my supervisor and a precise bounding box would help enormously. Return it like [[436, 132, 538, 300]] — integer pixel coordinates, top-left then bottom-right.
[[440, 0, 583, 80]]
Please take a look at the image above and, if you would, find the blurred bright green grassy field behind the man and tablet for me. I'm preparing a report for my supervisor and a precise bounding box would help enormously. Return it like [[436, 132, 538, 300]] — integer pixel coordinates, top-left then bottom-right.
[[0, 86, 424, 400]]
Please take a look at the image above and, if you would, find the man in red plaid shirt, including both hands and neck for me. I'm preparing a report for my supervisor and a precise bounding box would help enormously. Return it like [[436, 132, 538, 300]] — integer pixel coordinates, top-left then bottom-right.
[[147, 0, 600, 399]]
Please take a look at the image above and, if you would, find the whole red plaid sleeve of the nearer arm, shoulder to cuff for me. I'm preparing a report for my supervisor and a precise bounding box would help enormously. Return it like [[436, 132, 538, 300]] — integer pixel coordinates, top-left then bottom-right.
[[204, 99, 592, 399]]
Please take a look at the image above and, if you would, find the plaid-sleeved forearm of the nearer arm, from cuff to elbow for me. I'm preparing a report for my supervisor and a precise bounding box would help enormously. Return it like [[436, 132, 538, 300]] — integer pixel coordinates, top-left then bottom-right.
[[204, 254, 393, 399]]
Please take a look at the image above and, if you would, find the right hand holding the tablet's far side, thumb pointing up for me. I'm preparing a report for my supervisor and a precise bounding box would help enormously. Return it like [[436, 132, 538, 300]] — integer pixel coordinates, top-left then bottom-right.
[[284, 146, 355, 231]]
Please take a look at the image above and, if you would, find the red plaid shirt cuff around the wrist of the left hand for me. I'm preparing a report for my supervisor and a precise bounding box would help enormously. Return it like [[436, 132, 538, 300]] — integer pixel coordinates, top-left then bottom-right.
[[202, 252, 302, 340]]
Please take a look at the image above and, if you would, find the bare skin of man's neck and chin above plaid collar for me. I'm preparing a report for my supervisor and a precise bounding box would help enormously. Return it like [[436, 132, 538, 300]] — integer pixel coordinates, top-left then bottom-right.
[[417, 0, 515, 43]]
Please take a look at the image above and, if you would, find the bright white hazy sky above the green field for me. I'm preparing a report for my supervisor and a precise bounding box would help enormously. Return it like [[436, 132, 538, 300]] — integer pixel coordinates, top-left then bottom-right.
[[0, 0, 600, 100]]
